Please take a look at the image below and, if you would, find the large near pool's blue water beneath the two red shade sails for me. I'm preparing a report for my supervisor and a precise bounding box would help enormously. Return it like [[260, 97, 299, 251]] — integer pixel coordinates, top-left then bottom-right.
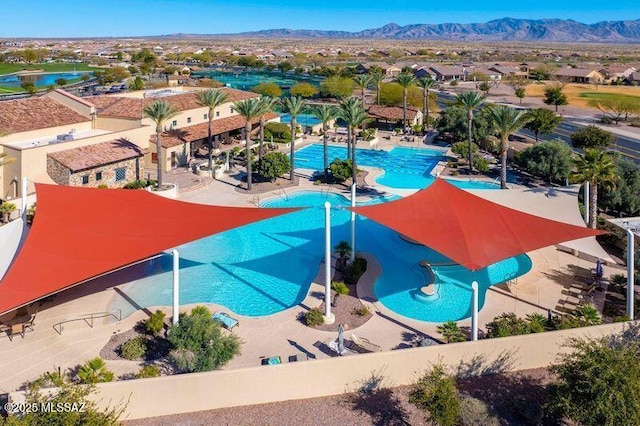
[[111, 191, 531, 322]]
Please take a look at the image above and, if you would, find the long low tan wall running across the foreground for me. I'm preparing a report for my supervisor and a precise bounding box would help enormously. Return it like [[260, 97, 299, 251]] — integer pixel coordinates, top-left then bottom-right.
[[86, 323, 624, 419]]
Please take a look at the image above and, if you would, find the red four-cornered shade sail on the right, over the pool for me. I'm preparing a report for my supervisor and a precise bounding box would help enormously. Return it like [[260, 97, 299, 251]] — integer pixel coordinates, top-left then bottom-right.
[[350, 179, 604, 270]]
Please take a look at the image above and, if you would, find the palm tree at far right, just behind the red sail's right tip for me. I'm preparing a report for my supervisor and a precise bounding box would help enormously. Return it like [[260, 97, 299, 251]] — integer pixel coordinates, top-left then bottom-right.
[[571, 148, 618, 229]]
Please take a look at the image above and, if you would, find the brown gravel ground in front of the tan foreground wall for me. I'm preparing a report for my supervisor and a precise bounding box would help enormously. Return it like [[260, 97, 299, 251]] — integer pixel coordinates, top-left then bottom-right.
[[125, 369, 553, 426]]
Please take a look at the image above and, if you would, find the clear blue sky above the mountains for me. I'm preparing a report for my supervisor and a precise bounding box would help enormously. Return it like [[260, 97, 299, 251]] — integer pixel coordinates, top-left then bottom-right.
[[0, 0, 640, 37]]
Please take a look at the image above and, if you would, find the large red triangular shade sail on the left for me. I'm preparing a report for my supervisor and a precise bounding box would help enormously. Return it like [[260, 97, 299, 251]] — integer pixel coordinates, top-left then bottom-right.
[[0, 184, 298, 314]]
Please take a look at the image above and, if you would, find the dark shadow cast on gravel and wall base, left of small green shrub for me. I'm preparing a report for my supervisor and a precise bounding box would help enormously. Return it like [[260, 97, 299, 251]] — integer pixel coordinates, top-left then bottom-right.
[[348, 371, 410, 426]]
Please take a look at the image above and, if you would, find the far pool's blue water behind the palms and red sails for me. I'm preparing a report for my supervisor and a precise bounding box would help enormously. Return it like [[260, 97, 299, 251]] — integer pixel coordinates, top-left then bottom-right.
[[295, 144, 499, 189]]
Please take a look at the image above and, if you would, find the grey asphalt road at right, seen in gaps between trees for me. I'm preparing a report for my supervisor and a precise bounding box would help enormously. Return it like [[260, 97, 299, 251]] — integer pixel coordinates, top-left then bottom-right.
[[437, 92, 640, 164]]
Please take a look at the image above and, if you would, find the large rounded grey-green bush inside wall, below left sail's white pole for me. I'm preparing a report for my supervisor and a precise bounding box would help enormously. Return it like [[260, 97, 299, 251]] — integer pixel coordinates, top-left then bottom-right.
[[168, 306, 240, 372]]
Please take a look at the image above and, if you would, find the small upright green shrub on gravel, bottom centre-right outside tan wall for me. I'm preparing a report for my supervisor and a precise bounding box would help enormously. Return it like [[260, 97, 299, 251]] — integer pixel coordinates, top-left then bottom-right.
[[409, 364, 460, 426]]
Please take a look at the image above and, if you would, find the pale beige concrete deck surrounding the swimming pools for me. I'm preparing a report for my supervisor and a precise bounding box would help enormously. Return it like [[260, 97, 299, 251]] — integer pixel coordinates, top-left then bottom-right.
[[0, 137, 618, 392]]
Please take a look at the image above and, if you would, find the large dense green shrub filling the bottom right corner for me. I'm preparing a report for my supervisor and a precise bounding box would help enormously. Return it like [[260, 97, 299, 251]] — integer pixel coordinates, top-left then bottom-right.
[[550, 330, 640, 426]]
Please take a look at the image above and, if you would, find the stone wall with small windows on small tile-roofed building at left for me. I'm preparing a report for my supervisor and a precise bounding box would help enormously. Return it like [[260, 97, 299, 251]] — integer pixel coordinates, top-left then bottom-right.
[[47, 156, 142, 188]]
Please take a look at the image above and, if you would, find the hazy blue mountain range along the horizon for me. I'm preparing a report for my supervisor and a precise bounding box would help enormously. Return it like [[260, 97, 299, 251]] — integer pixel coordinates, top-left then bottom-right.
[[205, 18, 640, 43]]
